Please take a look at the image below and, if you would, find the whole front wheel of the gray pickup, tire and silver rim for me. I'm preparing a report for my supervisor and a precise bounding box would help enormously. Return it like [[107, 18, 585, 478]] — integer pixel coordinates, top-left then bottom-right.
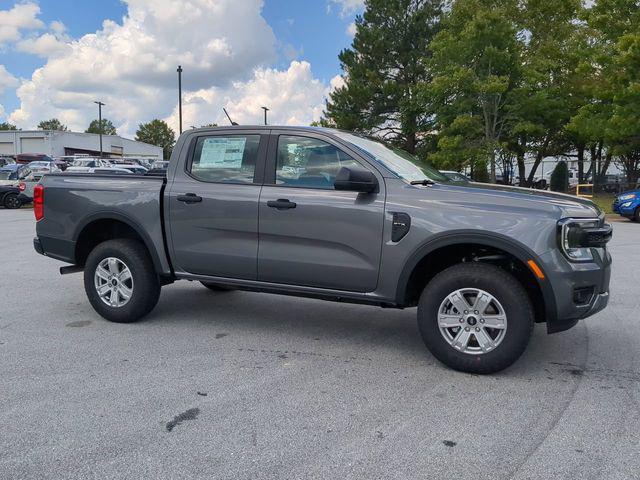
[[418, 263, 534, 373]]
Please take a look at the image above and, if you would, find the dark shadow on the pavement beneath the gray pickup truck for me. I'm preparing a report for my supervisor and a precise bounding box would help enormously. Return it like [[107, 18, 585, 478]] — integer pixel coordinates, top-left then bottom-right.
[[143, 282, 586, 377]]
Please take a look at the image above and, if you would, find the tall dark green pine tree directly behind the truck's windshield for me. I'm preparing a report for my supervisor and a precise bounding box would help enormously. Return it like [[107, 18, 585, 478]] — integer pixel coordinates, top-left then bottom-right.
[[322, 0, 443, 153]]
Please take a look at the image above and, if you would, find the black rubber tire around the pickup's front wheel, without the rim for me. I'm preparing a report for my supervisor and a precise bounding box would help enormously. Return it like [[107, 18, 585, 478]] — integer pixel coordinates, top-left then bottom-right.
[[418, 263, 534, 374]]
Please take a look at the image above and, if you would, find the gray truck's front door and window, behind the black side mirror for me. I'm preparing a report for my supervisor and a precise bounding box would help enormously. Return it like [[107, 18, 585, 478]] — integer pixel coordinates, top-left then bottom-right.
[[258, 131, 385, 292]]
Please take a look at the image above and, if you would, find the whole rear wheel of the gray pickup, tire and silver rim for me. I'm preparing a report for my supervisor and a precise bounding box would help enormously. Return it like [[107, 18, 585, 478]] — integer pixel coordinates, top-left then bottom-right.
[[84, 239, 160, 323]]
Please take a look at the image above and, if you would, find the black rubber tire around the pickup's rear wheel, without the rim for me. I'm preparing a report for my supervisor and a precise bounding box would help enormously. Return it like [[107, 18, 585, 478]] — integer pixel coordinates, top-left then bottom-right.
[[84, 239, 160, 323]]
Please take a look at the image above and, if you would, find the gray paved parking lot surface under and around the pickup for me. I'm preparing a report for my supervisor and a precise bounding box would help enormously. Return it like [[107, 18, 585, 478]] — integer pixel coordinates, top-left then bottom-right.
[[0, 210, 640, 480]]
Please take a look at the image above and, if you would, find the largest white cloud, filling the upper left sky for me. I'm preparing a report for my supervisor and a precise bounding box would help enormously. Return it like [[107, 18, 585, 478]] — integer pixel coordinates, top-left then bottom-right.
[[10, 0, 288, 135]]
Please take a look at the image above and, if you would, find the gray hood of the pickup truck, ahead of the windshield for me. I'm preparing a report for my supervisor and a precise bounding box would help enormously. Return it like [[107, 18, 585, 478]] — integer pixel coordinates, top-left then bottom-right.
[[432, 182, 602, 218]]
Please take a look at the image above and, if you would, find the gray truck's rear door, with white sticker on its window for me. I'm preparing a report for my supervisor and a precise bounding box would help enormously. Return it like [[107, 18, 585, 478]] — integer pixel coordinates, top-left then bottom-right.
[[168, 130, 268, 280]]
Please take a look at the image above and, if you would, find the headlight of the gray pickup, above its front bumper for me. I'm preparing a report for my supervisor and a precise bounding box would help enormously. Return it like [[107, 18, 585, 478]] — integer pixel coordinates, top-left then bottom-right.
[[558, 218, 612, 262]]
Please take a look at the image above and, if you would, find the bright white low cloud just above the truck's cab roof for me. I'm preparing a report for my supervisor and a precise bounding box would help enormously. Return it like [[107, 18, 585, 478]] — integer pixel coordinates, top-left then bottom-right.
[[165, 61, 328, 128]]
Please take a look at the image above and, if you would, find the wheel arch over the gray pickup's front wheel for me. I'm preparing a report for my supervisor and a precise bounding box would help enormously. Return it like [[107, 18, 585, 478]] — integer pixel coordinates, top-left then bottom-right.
[[396, 231, 556, 322]]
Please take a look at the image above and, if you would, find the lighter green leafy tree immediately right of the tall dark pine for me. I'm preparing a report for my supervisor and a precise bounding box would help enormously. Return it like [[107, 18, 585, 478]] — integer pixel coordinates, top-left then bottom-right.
[[424, 0, 520, 183]]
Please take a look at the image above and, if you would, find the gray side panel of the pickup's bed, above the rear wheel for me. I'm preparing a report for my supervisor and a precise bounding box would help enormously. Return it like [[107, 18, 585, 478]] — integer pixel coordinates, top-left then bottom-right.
[[37, 173, 171, 273]]
